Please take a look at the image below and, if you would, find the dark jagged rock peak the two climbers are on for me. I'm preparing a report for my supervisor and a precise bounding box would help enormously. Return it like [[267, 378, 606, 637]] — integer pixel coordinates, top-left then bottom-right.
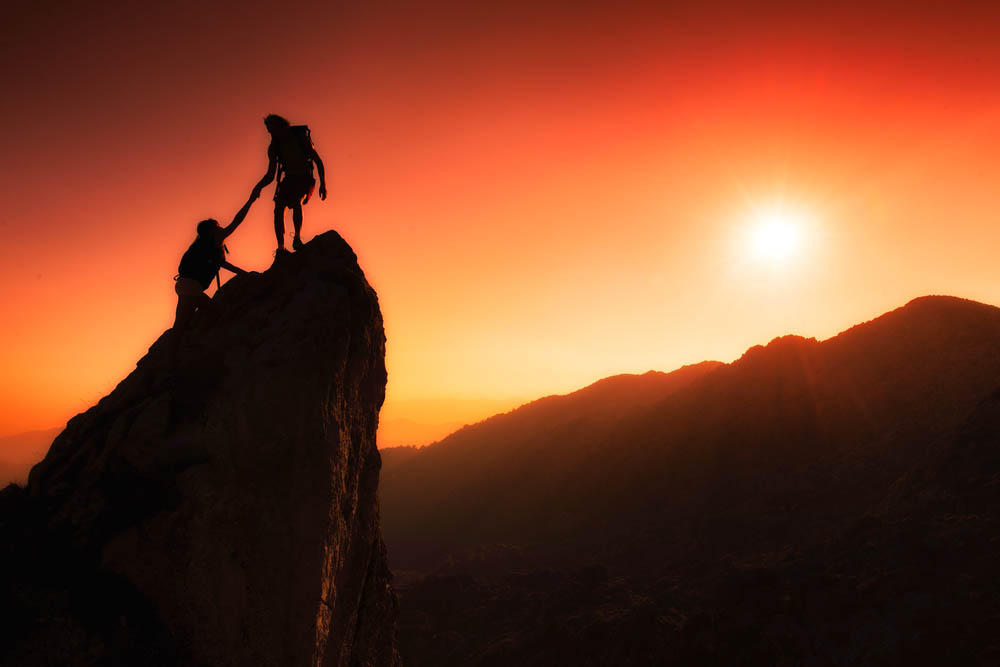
[[0, 232, 399, 666]]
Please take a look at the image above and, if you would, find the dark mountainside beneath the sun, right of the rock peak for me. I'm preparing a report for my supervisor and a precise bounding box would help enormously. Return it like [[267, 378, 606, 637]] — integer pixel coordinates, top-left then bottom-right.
[[381, 297, 1000, 665]]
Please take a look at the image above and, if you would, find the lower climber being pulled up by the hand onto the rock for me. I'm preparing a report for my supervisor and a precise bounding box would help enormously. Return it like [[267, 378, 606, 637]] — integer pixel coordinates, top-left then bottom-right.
[[174, 188, 260, 342]]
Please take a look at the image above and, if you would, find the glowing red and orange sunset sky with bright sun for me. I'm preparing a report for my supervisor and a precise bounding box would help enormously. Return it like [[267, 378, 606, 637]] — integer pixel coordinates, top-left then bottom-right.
[[0, 0, 1000, 444]]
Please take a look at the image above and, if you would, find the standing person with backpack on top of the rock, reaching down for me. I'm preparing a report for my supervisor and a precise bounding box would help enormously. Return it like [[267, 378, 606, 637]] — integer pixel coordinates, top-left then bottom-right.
[[254, 114, 326, 254]]
